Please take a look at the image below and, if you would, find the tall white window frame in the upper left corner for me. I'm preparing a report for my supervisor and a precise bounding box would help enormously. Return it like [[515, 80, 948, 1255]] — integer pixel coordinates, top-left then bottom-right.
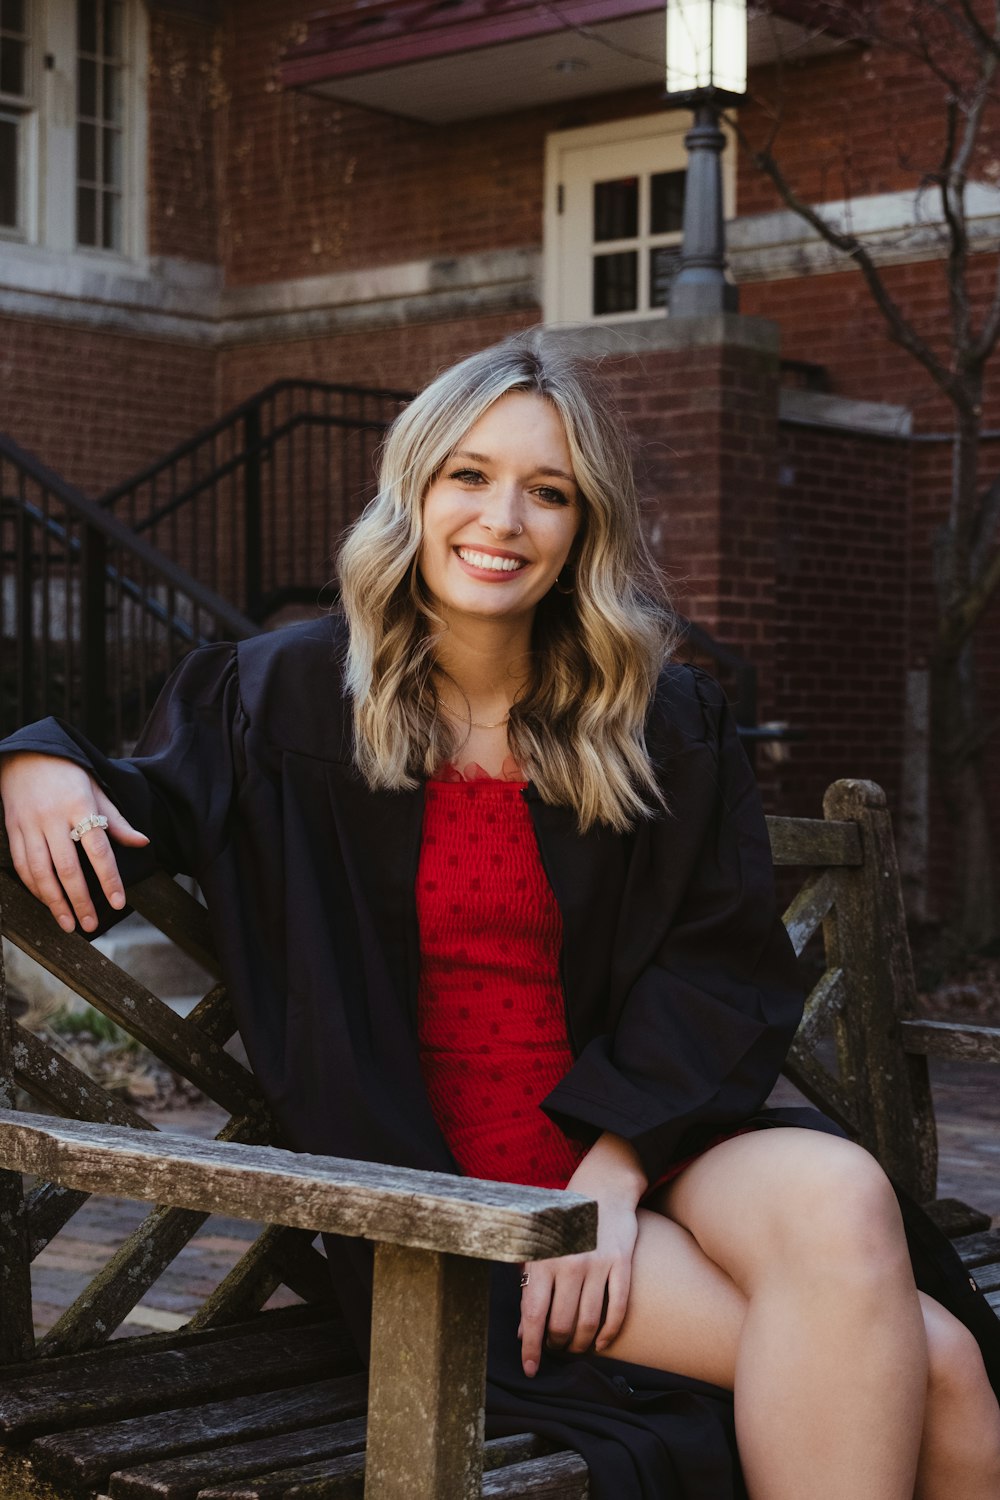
[[0, 0, 148, 267]]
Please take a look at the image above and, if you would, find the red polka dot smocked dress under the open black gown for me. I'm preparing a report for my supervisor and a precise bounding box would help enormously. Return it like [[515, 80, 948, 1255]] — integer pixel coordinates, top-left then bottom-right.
[[417, 762, 583, 1188]]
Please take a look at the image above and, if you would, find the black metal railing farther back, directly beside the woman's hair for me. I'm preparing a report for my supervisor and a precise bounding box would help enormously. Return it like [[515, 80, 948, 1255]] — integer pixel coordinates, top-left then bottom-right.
[[100, 380, 411, 621]]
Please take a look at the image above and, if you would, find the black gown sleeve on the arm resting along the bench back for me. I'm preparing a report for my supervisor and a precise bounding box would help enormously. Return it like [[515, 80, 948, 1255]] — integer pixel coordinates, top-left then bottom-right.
[[0, 644, 246, 888]]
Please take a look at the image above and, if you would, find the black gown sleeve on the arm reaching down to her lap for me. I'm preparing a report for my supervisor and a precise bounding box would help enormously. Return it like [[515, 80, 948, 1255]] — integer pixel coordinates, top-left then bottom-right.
[[544, 672, 802, 1181]]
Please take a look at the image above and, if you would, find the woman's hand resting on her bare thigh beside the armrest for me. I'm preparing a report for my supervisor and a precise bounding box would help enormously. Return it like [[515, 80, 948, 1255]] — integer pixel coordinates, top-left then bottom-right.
[[517, 1134, 646, 1376]]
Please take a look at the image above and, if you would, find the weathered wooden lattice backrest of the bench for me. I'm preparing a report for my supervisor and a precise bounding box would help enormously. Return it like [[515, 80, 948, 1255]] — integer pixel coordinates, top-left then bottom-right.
[[0, 782, 936, 1364]]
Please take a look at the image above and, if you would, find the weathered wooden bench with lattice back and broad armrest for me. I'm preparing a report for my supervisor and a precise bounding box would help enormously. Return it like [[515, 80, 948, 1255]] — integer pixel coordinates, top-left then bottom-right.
[[0, 782, 1000, 1500]]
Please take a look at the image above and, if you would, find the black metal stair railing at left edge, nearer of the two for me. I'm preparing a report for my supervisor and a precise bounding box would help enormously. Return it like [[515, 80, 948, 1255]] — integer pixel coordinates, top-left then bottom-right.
[[0, 435, 258, 753]]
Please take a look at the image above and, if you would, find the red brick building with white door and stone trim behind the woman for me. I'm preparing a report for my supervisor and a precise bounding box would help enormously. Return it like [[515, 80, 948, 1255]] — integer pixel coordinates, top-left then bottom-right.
[[0, 0, 1000, 917]]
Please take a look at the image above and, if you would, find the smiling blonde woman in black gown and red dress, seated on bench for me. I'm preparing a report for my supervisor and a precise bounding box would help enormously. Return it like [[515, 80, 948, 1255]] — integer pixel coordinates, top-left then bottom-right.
[[0, 339, 1000, 1500]]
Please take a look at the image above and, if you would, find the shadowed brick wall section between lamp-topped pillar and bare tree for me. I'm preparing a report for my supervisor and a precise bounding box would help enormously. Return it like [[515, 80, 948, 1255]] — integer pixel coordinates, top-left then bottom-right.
[[775, 423, 910, 816]]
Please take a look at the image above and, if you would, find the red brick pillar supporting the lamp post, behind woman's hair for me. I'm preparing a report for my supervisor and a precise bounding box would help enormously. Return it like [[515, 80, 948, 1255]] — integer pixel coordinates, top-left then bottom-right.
[[552, 314, 780, 719]]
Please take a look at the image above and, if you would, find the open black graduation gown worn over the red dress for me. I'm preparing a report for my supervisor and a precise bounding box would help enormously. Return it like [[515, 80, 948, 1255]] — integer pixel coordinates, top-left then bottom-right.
[[0, 618, 991, 1500]]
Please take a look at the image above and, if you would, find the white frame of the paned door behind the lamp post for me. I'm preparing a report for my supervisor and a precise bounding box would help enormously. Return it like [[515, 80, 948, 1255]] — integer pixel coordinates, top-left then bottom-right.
[[543, 110, 736, 324]]
